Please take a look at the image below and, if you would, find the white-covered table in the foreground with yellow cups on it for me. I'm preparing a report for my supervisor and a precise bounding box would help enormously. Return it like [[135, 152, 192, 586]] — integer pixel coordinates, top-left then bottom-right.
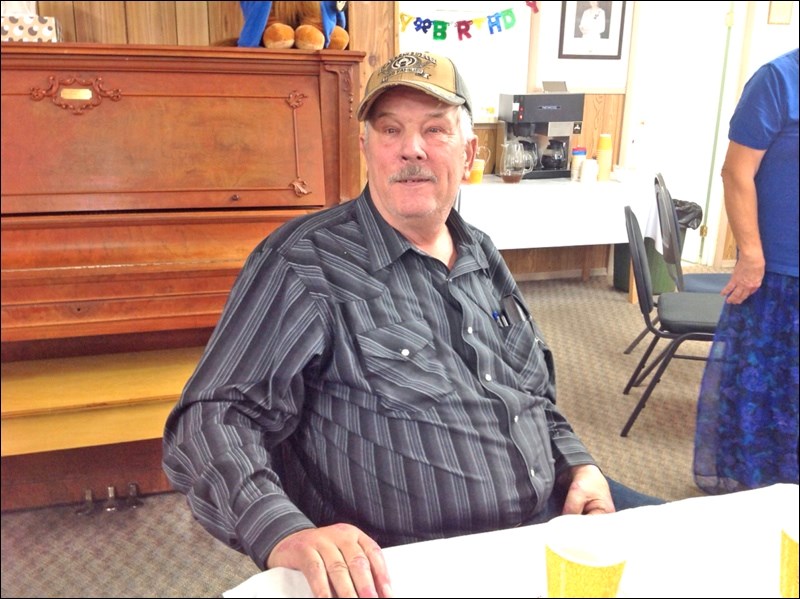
[[224, 485, 800, 598]]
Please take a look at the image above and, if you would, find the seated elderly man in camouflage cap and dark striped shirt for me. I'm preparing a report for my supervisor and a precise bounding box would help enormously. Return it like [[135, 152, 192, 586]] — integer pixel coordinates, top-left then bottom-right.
[[164, 52, 658, 597]]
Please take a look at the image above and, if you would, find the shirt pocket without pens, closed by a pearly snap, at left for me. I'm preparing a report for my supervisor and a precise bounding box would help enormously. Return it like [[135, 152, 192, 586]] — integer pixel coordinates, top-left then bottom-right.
[[356, 320, 453, 412]]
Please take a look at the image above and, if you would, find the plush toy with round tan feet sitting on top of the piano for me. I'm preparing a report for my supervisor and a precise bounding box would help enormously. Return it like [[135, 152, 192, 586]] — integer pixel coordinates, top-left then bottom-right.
[[238, 1, 350, 50]]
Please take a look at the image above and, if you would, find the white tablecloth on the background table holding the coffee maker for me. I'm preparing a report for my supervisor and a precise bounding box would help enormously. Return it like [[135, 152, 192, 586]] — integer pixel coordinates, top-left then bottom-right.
[[457, 173, 661, 250]]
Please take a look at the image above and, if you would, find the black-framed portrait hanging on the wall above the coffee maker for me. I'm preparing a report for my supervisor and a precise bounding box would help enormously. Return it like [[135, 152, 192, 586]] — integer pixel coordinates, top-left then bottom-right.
[[558, 1, 627, 60]]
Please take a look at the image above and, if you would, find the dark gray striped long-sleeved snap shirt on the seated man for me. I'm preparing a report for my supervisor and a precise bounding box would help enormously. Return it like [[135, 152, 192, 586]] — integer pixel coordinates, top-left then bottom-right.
[[164, 191, 594, 568]]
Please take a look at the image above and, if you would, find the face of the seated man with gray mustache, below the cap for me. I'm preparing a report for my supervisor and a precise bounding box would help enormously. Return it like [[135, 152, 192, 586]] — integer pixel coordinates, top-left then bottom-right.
[[361, 87, 477, 231]]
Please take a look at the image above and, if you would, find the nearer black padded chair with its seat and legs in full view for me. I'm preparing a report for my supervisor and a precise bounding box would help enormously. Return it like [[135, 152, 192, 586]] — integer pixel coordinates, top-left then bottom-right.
[[620, 206, 725, 437]]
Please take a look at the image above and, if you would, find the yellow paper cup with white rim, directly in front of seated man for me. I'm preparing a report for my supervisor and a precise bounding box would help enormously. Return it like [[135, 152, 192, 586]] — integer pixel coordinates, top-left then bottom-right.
[[545, 515, 625, 597]]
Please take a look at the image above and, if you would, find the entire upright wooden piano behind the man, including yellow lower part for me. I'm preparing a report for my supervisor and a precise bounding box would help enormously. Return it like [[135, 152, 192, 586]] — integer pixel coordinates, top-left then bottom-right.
[[0, 43, 364, 509]]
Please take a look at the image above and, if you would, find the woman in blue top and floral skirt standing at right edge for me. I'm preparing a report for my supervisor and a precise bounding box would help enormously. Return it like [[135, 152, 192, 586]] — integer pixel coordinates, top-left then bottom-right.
[[694, 49, 800, 493]]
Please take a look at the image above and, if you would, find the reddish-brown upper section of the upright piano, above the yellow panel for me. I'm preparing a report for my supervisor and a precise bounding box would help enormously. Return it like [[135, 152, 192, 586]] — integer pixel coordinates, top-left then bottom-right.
[[2, 43, 364, 359]]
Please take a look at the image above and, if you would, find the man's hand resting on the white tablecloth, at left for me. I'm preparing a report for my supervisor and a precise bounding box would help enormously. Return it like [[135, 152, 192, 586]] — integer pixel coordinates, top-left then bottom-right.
[[266, 524, 393, 597]]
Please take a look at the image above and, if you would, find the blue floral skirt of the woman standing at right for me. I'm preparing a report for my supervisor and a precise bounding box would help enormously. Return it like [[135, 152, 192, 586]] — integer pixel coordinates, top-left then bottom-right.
[[694, 273, 800, 494]]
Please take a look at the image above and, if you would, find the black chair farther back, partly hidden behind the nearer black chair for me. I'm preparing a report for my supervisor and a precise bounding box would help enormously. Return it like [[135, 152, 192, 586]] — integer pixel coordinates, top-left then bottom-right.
[[623, 173, 730, 354]]
